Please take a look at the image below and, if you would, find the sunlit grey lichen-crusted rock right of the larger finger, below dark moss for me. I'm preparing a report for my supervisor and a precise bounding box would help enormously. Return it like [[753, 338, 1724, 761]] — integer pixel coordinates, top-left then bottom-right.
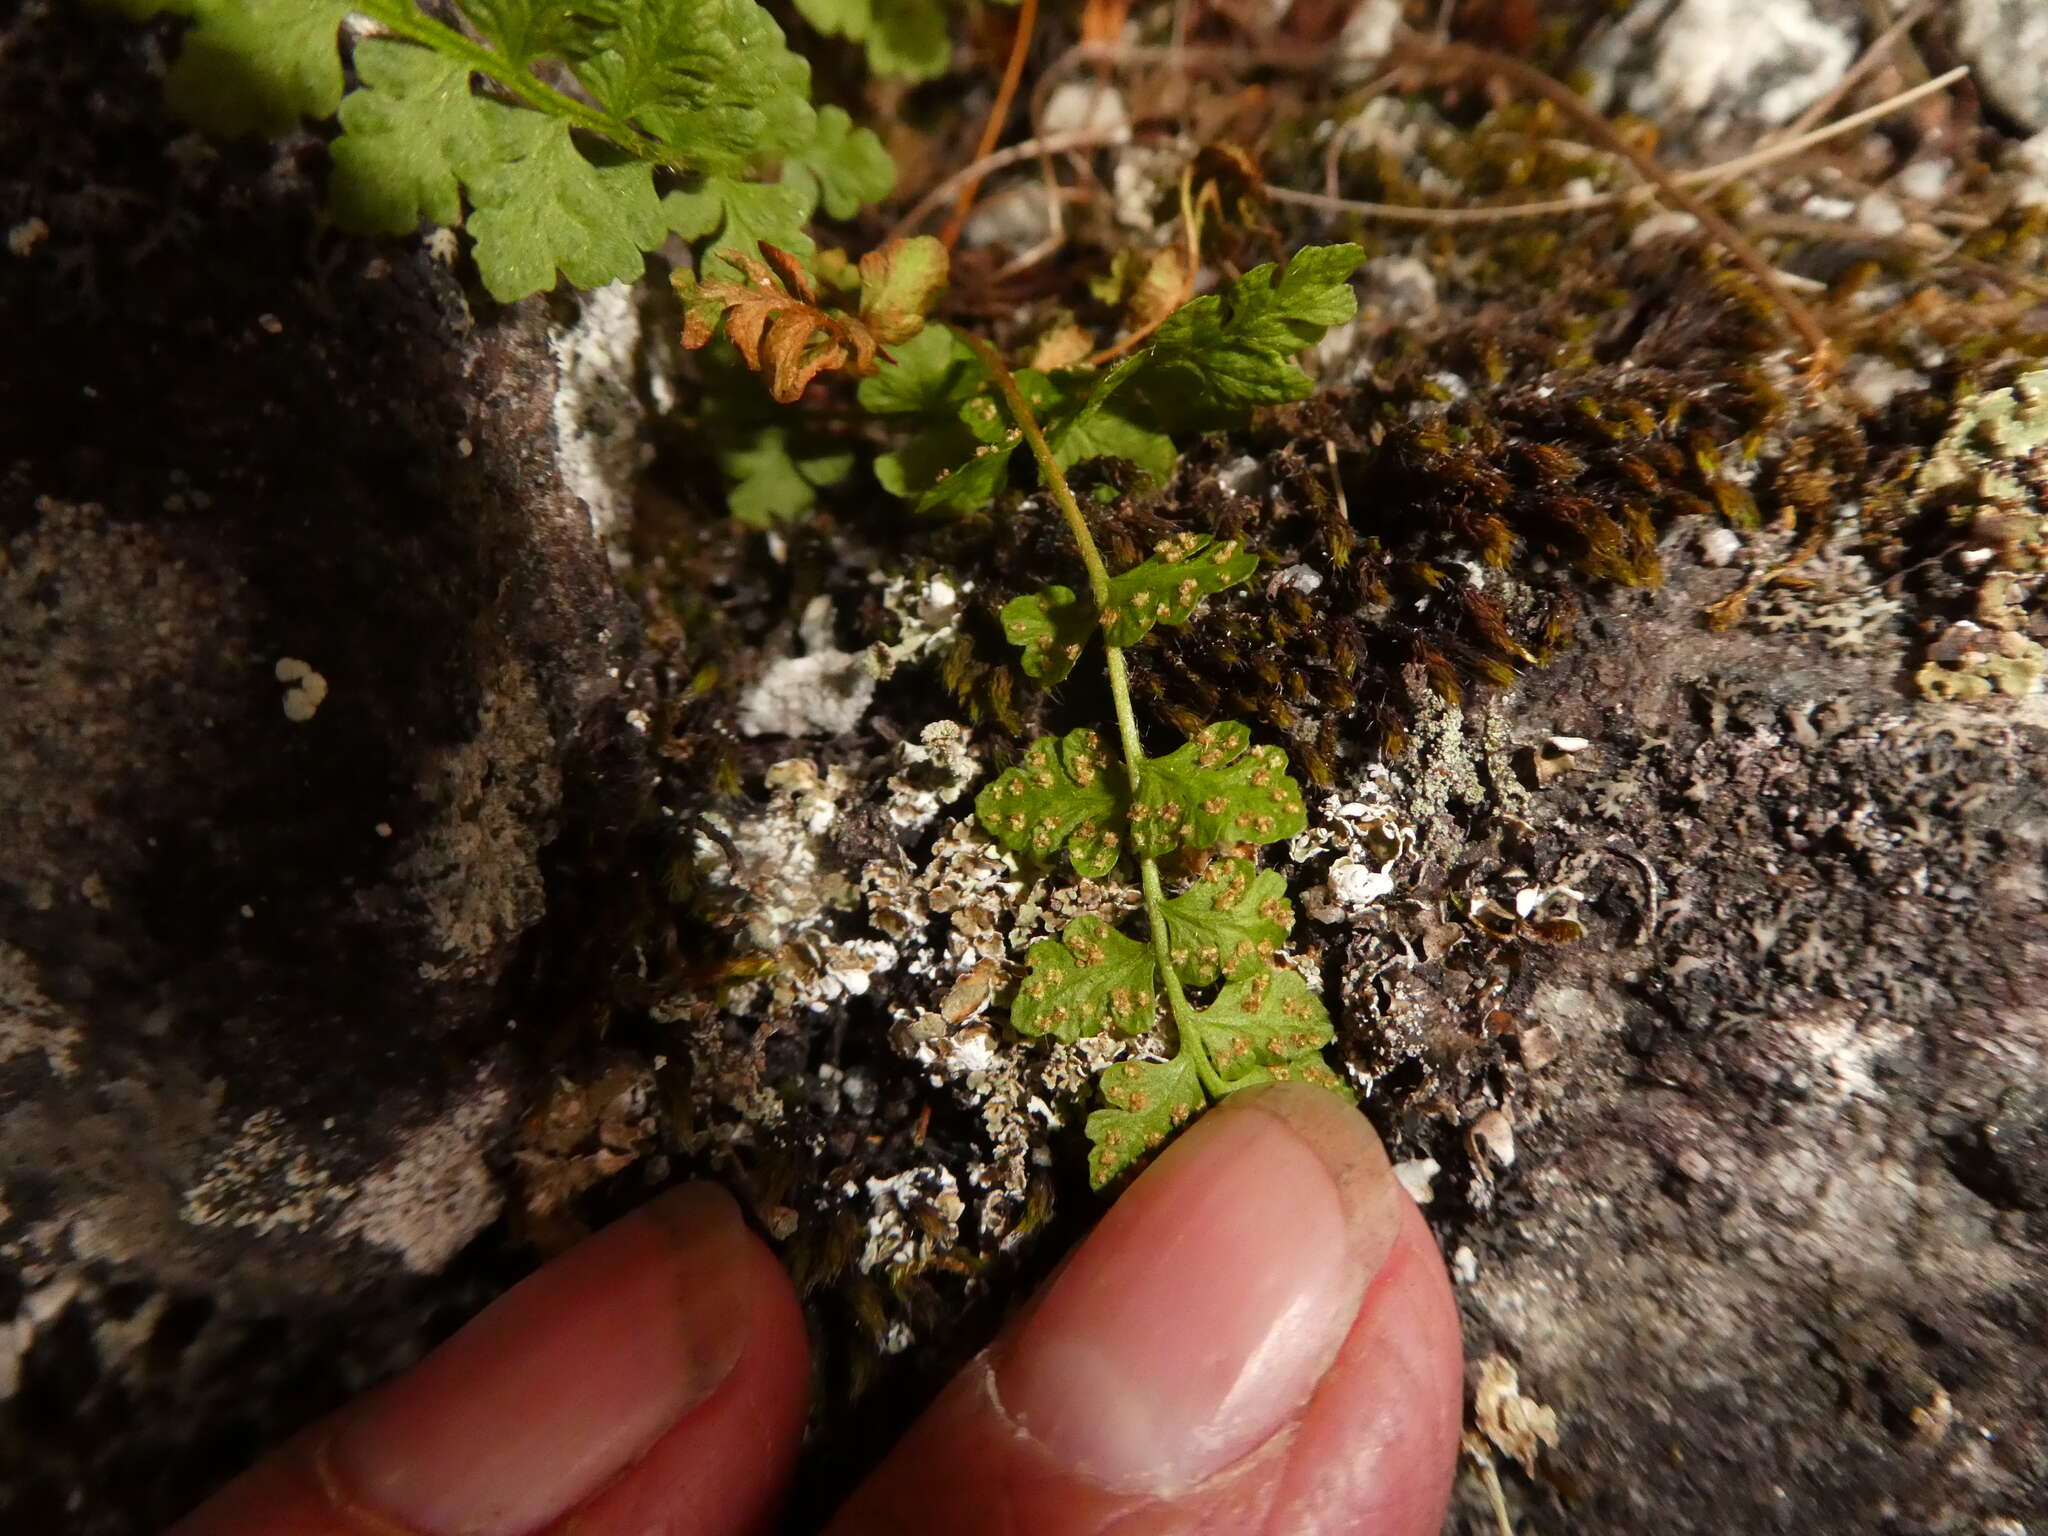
[[1441, 561, 2048, 1536]]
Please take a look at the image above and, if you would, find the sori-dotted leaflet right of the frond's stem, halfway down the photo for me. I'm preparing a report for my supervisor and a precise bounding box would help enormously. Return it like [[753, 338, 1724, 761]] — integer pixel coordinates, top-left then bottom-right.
[[1130, 721, 1309, 858]]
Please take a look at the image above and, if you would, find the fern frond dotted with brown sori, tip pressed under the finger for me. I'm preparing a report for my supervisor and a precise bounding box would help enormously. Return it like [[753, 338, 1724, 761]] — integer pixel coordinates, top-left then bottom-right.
[[954, 319, 1358, 1188]]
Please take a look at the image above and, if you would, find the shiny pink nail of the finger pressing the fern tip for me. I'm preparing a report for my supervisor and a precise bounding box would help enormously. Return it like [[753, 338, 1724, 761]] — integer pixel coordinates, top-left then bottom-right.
[[993, 1083, 1407, 1495]]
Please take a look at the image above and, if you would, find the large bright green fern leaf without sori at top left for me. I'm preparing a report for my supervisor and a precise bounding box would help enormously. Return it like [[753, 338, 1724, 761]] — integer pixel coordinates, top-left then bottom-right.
[[140, 0, 895, 299]]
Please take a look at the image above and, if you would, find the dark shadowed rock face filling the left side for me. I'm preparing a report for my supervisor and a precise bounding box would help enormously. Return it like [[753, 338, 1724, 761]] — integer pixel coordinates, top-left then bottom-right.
[[0, 4, 639, 1532]]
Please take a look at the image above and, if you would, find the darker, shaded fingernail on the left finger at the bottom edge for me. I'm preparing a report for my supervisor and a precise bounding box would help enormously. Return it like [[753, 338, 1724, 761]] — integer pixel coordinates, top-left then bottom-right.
[[322, 1186, 754, 1536]]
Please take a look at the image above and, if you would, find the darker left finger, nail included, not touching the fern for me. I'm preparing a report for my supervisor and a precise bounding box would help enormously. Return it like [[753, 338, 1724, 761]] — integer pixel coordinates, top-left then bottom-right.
[[174, 1186, 809, 1536]]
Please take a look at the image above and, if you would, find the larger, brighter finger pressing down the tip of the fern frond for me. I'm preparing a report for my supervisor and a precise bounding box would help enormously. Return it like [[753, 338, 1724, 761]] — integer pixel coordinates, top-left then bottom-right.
[[831, 1083, 1462, 1536]]
